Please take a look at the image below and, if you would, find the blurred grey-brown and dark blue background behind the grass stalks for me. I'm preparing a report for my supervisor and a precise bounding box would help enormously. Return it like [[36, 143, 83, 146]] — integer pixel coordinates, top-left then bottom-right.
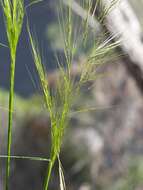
[[0, 0, 143, 190]]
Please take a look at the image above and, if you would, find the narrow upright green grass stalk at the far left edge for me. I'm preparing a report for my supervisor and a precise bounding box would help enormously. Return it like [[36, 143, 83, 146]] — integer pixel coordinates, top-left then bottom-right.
[[1, 0, 24, 190]]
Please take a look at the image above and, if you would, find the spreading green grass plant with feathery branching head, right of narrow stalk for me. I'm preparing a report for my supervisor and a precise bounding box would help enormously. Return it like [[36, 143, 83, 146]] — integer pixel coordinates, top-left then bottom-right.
[[28, 0, 119, 190]]
